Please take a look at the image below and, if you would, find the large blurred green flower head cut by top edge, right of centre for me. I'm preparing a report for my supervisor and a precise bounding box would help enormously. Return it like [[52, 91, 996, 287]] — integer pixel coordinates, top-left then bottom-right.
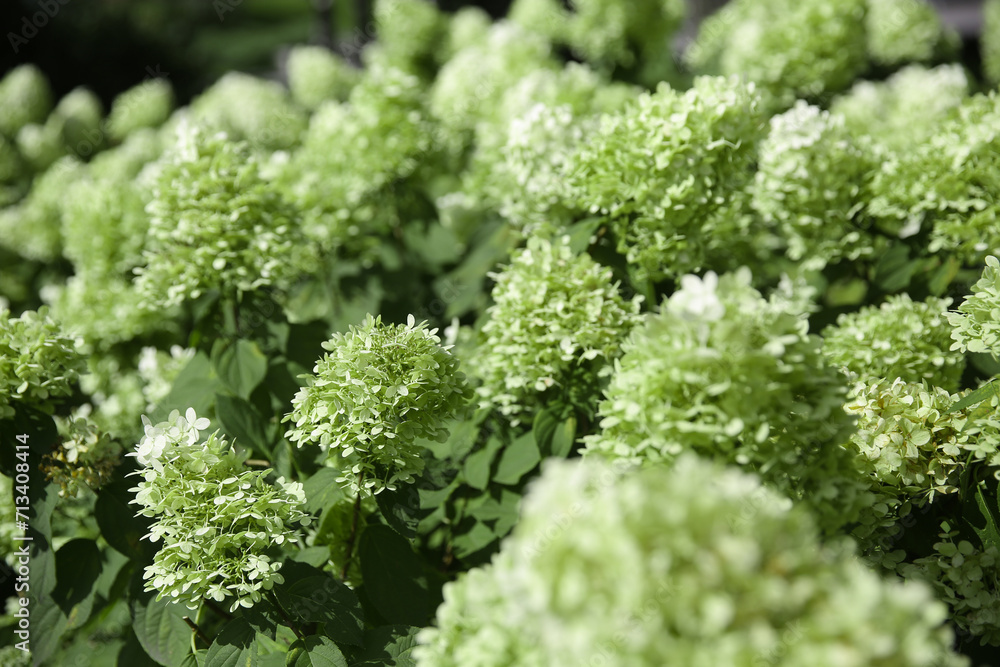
[[685, 0, 868, 109]]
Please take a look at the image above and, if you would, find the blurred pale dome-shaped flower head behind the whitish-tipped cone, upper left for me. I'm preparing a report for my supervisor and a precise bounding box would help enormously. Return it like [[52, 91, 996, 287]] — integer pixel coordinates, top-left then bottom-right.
[[190, 72, 308, 152]]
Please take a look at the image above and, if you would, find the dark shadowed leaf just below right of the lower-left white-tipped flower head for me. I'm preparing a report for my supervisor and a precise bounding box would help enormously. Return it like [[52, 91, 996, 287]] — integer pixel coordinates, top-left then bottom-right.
[[275, 561, 365, 645]]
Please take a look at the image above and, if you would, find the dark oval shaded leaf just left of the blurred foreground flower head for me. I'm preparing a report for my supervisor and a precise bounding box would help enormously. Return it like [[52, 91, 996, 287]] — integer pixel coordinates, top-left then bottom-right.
[[358, 525, 440, 627]]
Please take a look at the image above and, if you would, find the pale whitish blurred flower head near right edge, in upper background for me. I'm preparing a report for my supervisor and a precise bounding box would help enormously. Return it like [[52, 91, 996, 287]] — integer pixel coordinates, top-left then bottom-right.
[[830, 64, 969, 150]]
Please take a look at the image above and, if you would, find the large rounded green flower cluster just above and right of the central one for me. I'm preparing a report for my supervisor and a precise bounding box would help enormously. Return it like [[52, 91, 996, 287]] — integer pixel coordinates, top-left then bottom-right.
[[569, 77, 764, 280]]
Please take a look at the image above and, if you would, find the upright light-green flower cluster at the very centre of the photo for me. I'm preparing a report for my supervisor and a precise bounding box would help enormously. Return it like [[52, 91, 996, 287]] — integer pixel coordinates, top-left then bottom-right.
[[471, 237, 642, 424]]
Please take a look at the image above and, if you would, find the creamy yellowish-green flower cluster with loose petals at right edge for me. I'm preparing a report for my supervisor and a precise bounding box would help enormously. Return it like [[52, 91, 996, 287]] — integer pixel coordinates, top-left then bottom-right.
[[845, 378, 1000, 500]]
